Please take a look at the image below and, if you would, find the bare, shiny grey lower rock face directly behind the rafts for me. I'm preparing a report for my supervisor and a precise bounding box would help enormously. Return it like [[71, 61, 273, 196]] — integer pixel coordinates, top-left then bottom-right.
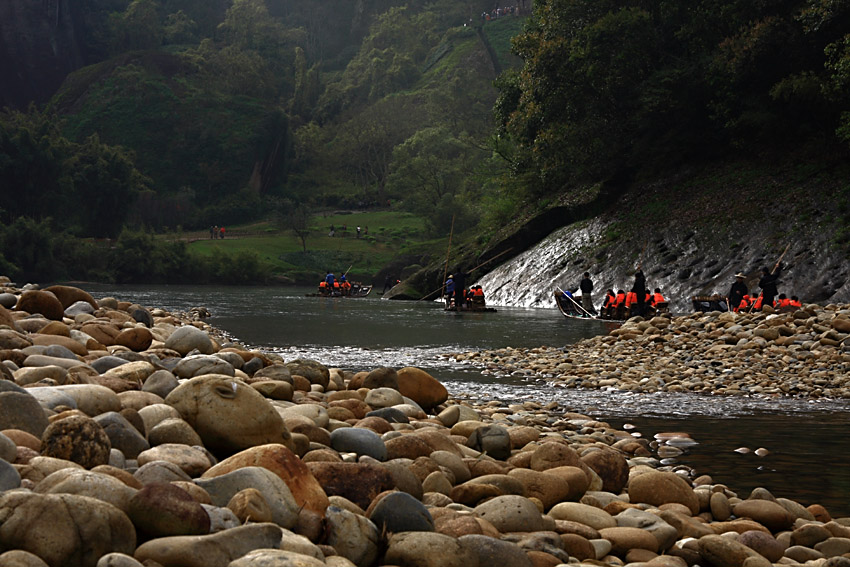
[[477, 214, 850, 312]]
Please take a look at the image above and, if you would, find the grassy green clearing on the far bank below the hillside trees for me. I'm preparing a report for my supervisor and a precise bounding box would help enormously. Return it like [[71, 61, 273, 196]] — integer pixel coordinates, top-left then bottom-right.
[[183, 211, 430, 282]]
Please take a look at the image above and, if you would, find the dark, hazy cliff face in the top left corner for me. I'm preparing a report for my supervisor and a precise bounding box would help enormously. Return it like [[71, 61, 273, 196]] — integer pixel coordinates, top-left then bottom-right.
[[0, 0, 86, 109]]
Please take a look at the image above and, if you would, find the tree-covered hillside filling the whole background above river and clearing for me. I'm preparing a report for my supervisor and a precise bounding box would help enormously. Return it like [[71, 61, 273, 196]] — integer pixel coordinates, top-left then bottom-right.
[[0, 0, 850, 286]]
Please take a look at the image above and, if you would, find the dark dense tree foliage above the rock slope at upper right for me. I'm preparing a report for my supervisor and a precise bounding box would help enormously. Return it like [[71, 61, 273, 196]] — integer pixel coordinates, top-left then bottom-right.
[[496, 0, 850, 191]]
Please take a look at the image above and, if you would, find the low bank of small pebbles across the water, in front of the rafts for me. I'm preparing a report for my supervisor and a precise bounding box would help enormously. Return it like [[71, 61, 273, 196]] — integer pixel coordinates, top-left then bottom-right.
[[447, 305, 850, 399]]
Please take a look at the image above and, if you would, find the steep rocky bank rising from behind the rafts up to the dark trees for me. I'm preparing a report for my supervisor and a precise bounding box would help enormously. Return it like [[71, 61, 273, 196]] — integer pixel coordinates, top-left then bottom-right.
[[390, 154, 850, 311]]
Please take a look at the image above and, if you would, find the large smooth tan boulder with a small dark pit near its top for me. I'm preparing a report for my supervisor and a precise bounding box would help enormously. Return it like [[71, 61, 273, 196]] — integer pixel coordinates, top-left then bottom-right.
[[165, 374, 294, 455]]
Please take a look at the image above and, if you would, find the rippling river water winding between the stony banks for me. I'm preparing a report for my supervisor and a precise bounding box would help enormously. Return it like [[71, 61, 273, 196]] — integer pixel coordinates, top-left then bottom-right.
[[78, 284, 850, 517]]
